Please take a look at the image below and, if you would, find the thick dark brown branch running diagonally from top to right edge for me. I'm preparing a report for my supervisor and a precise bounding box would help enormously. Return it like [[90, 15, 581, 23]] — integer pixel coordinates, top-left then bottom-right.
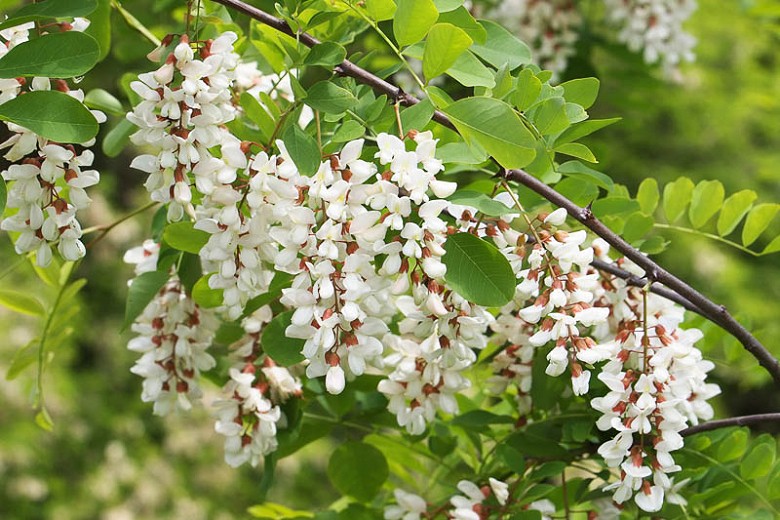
[[214, 0, 780, 385]]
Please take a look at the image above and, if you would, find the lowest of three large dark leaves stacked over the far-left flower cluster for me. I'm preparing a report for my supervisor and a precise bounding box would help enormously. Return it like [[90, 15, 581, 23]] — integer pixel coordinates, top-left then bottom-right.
[[0, 90, 98, 143]]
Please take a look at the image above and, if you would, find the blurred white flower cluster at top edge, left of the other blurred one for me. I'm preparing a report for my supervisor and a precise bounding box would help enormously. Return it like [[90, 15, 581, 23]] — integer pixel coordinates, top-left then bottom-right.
[[487, 0, 582, 77]]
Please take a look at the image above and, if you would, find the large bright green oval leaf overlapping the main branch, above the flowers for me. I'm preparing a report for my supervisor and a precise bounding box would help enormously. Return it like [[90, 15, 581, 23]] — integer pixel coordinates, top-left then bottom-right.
[[444, 97, 536, 169]]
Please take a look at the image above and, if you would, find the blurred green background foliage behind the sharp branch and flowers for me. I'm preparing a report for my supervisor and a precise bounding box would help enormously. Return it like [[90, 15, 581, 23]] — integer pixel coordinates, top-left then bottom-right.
[[0, 0, 780, 520]]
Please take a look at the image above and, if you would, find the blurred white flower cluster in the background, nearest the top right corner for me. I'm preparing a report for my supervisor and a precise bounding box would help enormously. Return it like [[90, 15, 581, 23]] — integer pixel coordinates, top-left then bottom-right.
[[604, 0, 697, 71]]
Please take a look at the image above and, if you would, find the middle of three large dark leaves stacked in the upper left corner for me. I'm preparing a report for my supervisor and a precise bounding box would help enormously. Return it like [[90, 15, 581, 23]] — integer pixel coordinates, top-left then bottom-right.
[[0, 31, 100, 78]]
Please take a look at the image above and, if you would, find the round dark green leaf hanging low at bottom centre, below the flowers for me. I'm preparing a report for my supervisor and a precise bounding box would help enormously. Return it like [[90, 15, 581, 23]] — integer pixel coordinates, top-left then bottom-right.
[[328, 441, 390, 502]]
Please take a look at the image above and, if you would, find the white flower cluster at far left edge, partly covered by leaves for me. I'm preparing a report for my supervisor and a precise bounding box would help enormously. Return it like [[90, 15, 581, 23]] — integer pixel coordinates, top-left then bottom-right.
[[0, 18, 106, 267]]
